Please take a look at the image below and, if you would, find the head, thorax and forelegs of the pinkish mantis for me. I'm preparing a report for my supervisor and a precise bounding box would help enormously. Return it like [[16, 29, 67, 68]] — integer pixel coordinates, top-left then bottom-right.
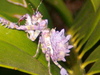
[[0, 11, 48, 41]]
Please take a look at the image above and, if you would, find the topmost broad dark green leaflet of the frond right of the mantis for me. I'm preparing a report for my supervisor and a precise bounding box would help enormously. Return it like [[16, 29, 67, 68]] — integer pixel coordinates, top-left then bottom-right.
[[69, 0, 100, 37]]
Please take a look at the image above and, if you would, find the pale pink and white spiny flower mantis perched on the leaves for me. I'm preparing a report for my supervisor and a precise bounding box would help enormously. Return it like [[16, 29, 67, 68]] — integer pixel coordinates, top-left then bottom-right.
[[0, 11, 73, 75]]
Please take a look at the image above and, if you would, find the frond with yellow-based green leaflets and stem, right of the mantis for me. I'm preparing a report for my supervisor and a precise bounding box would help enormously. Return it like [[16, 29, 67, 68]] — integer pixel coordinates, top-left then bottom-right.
[[68, 0, 100, 75]]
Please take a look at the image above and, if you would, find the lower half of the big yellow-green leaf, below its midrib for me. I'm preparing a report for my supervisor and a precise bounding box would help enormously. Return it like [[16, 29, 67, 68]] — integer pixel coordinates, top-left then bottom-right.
[[0, 40, 48, 75]]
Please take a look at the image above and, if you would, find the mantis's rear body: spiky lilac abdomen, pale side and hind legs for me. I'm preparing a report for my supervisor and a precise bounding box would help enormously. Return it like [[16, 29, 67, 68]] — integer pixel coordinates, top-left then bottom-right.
[[39, 29, 73, 75]]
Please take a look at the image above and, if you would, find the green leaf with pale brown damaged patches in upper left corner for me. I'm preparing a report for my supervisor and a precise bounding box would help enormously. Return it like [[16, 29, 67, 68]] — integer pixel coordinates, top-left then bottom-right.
[[0, 0, 28, 22]]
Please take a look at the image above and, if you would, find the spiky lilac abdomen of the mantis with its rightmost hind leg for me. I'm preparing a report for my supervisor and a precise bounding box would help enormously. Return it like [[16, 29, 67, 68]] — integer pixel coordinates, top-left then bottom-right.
[[50, 29, 73, 75]]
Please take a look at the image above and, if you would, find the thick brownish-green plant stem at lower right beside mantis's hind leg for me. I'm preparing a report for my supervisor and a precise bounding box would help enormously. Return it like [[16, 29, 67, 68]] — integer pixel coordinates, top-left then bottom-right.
[[70, 50, 85, 75]]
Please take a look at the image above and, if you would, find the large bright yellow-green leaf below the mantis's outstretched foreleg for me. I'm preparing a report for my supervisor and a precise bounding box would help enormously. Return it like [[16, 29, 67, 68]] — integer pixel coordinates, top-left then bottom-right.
[[0, 26, 48, 75]]
